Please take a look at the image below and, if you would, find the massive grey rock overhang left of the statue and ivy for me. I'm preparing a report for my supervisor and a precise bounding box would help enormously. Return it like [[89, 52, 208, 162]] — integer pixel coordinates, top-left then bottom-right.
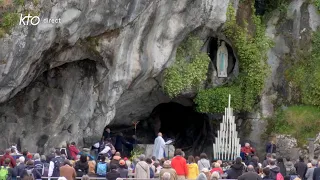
[[0, 0, 229, 152]]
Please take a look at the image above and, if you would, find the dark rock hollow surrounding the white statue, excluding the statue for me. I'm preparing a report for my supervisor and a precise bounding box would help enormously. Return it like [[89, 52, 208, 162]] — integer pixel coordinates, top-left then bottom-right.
[[207, 37, 236, 76]]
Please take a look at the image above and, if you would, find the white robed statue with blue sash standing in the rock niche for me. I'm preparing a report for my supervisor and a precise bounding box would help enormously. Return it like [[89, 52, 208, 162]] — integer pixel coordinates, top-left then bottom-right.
[[217, 41, 228, 77]]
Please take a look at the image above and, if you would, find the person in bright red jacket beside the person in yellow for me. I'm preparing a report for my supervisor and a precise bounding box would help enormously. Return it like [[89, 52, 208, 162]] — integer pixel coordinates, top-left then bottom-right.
[[171, 149, 188, 180]]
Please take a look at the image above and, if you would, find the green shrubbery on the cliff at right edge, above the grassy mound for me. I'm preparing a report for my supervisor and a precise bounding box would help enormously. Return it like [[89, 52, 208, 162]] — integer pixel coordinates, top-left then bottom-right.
[[286, 30, 320, 106]]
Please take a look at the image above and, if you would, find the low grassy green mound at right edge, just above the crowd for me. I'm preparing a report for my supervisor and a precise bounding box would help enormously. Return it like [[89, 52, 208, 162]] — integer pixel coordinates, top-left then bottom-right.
[[267, 106, 320, 145]]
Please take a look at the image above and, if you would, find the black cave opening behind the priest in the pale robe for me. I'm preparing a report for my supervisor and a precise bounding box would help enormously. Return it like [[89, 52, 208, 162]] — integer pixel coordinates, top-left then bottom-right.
[[107, 101, 217, 156]]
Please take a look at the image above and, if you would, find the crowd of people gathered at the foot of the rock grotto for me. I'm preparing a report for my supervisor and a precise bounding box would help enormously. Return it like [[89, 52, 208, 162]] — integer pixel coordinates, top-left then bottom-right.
[[0, 129, 320, 180]]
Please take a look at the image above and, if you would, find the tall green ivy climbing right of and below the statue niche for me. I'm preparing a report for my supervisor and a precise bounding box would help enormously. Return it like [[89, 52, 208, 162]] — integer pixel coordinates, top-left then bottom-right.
[[195, 5, 272, 113]]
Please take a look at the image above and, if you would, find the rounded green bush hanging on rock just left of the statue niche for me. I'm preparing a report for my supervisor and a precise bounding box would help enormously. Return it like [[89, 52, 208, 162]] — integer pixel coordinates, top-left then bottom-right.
[[164, 36, 210, 98]]
